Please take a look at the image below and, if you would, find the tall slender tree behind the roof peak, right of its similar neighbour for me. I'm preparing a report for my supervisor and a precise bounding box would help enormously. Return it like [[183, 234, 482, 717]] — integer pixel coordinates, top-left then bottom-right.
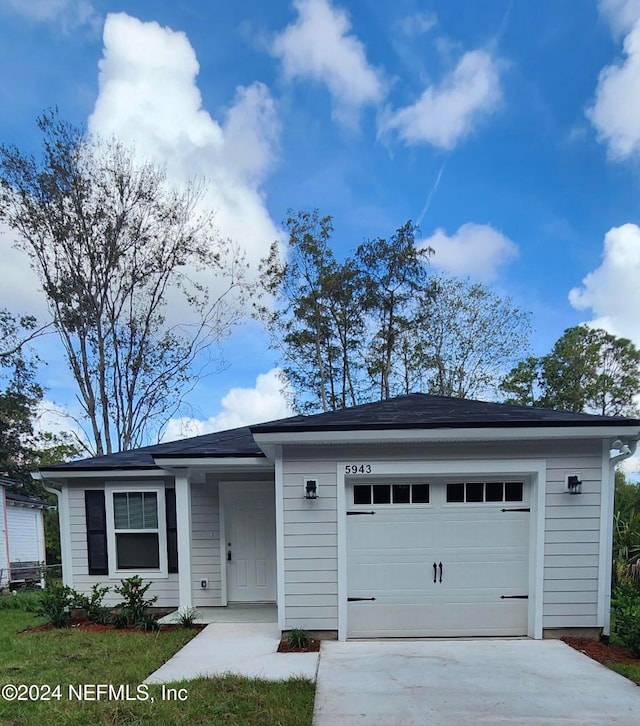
[[355, 221, 433, 400]]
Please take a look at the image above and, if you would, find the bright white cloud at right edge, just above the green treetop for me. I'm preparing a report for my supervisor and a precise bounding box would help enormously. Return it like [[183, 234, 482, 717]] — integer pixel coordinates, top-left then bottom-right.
[[569, 224, 640, 346]]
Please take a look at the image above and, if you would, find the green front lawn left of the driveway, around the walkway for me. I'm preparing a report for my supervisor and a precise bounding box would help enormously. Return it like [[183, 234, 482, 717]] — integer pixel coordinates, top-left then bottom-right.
[[0, 606, 314, 726]]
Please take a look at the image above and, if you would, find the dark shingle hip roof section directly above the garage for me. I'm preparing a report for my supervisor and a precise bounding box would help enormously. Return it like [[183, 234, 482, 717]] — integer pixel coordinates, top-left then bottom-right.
[[251, 393, 640, 433]]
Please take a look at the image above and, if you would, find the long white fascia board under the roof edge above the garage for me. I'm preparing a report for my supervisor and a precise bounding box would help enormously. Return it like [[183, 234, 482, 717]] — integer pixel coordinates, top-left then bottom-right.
[[253, 424, 640, 448]]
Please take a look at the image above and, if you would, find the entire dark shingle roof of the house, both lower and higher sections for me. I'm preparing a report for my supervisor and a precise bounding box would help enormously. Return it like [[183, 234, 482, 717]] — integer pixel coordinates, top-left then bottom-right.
[[44, 393, 640, 471]]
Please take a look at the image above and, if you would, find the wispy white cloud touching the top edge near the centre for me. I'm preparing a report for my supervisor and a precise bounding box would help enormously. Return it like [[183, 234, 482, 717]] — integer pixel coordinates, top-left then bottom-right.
[[271, 0, 384, 126]]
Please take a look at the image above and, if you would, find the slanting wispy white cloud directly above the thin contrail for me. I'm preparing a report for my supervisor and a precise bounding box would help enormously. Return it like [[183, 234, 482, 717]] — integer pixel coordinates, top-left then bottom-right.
[[381, 50, 502, 150]]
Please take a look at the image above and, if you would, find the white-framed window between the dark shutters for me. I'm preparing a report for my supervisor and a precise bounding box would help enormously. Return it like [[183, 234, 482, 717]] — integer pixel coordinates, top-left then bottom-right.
[[106, 484, 170, 577]]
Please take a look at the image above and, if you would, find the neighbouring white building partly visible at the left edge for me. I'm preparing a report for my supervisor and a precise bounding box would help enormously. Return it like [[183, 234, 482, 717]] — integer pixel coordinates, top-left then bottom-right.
[[0, 477, 52, 589]]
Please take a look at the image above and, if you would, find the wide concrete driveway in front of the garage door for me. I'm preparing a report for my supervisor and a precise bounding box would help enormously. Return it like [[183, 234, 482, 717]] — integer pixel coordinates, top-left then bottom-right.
[[313, 639, 640, 726]]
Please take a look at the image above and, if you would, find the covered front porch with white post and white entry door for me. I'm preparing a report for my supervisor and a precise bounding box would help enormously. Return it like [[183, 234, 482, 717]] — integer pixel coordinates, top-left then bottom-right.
[[156, 457, 278, 624]]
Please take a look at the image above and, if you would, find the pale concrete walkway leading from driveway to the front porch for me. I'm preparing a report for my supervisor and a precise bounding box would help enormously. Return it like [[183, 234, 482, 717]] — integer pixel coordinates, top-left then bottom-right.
[[145, 622, 319, 683]]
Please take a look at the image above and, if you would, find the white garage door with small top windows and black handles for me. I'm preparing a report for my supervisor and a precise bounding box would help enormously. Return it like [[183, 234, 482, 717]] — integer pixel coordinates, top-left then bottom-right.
[[347, 479, 530, 638]]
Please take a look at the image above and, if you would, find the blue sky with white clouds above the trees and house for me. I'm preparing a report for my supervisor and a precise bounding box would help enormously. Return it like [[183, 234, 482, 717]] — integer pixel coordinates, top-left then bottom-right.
[[0, 0, 640, 446]]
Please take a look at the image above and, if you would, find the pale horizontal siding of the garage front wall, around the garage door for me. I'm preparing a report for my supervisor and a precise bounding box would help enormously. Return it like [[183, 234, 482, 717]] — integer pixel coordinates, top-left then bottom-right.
[[283, 440, 603, 630]]
